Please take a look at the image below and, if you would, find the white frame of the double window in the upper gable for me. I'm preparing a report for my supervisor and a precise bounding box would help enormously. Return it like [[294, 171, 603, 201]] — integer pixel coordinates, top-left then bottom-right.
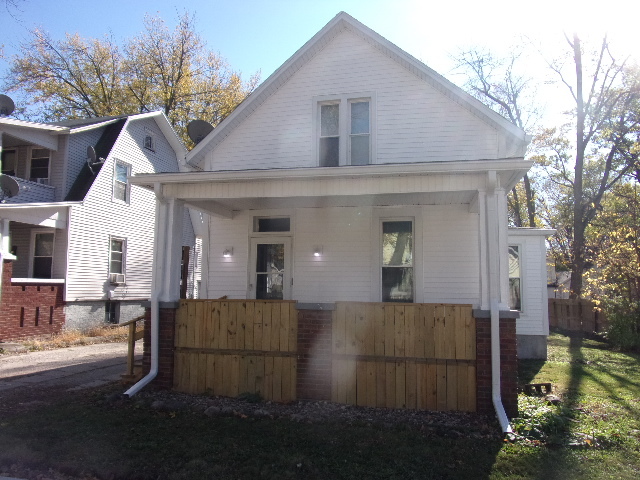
[[312, 92, 377, 168]]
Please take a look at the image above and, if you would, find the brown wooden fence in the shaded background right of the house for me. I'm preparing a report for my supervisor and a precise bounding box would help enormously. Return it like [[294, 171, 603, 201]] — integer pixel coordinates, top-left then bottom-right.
[[549, 298, 607, 333]]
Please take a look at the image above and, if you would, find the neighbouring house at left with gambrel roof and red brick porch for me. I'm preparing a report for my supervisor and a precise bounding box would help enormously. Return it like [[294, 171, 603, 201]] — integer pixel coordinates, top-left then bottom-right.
[[0, 112, 198, 339]]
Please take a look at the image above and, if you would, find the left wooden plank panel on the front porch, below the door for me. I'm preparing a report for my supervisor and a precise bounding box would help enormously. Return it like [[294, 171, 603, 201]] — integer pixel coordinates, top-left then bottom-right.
[[174, 300, 298, 402]]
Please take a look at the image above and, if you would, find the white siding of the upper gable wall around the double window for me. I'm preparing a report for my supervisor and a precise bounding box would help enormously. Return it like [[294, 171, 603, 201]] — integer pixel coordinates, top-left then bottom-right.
[[205, 32, 499, 170]]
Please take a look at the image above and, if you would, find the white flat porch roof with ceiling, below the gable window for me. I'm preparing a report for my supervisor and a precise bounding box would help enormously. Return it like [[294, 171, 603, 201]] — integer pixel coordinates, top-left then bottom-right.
[[130, 158, 531, 218]]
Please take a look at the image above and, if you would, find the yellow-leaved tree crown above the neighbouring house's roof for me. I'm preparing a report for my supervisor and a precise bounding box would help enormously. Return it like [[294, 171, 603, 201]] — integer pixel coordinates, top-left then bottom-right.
[[6, 13, 259, 144]]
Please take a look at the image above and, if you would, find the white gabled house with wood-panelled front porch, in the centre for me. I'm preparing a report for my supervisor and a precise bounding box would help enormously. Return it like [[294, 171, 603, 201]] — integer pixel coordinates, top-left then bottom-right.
[[128, 13, 548, 428]]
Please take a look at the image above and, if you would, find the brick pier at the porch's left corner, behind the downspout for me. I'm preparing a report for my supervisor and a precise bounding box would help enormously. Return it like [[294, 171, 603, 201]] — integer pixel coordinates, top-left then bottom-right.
[[142, 307, 176, 389]]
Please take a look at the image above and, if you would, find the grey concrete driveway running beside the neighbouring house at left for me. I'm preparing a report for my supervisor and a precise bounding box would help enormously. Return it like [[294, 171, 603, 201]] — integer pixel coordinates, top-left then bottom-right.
[[0, 343, 141, 394]]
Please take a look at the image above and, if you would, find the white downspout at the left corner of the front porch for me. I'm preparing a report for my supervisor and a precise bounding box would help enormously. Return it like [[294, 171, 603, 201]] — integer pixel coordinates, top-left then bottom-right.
[[124, 183, 166, 397]]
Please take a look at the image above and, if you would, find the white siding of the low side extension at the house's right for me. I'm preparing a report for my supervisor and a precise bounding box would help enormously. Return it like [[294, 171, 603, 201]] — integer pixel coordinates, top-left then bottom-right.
[[509, 230, 549, 335]]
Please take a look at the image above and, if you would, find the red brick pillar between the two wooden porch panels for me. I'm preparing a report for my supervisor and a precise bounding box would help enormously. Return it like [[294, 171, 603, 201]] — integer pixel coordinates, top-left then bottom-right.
[[297, 310, 332, 400]]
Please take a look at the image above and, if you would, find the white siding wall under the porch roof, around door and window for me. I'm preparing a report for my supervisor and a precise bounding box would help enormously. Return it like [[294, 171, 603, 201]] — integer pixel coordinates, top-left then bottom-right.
[[202, 205, 479, 304]]
